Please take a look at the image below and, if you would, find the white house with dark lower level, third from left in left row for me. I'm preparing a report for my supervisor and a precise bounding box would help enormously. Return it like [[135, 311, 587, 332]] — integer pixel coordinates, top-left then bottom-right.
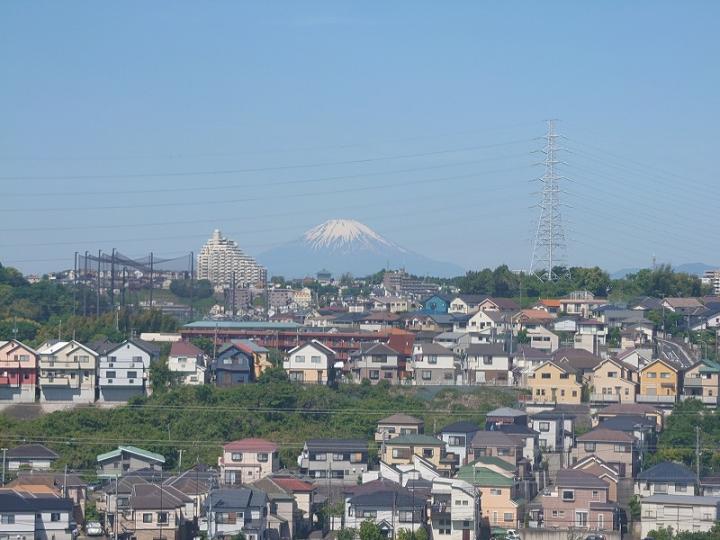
[[98, 339, 160, 403]]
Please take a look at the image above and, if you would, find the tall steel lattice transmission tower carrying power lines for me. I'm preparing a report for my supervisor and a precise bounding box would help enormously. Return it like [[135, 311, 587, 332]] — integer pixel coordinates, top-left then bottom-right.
[[530, 120, 565, 281]]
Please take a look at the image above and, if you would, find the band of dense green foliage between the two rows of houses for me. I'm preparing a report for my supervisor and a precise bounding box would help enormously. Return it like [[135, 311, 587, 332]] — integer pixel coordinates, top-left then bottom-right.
[[0, 378, 517, 470]]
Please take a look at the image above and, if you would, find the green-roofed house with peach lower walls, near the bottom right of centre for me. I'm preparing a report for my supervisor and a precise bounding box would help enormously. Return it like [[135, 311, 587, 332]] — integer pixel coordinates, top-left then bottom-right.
[[455, 462, 521, 529]]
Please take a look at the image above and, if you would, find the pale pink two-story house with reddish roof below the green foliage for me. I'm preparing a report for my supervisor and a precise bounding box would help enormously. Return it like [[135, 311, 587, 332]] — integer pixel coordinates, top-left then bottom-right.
[[218, 439, 280, 486]]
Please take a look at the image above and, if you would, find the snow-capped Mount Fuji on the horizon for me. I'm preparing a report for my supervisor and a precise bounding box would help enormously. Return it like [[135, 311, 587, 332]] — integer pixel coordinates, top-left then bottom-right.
[[258, 219, 463, 278]]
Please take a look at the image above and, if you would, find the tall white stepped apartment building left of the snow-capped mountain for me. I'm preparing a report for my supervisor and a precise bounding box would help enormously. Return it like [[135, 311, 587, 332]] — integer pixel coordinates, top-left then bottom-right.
[[198, 229, 267, 287]]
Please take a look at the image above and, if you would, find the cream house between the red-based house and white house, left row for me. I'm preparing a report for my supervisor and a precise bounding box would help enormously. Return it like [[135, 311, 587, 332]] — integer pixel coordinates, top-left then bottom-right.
[[37, 340, 97, 403]]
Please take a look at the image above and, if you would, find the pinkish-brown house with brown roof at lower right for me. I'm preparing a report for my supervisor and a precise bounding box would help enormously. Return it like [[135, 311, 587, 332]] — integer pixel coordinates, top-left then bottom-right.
[[530, 469, 620, 531]]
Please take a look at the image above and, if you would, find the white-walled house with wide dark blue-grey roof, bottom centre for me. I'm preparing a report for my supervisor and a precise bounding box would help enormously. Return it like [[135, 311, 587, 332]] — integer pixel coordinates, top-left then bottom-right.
[[344, 478, 426, 538]]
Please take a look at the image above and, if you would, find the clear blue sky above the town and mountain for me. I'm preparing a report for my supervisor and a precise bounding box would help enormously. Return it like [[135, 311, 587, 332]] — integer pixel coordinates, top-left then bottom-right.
[[0, 1, 720, 272]]
